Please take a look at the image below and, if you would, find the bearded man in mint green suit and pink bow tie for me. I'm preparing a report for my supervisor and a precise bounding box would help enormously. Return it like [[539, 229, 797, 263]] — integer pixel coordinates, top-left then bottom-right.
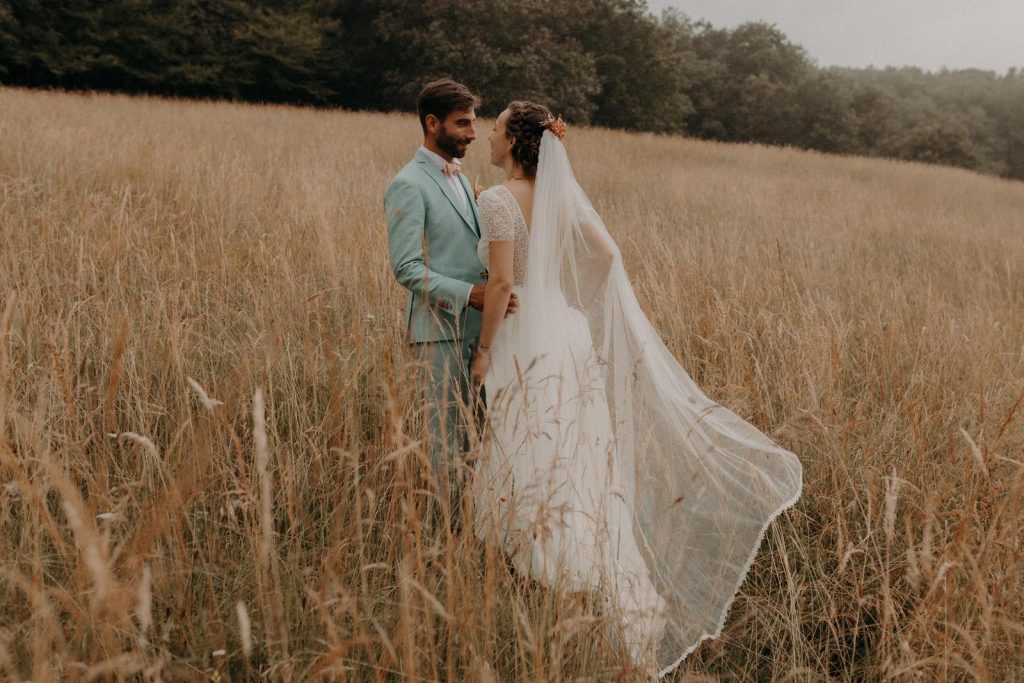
[[384, 79, 517, 510]]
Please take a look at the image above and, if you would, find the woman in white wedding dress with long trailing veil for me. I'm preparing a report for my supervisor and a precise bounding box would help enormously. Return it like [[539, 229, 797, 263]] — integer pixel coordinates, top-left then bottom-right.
[[470, 101, 802, 675]]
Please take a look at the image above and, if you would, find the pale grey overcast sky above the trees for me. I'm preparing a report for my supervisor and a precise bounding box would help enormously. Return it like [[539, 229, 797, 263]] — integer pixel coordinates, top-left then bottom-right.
[[647, 0, 1024, 74]]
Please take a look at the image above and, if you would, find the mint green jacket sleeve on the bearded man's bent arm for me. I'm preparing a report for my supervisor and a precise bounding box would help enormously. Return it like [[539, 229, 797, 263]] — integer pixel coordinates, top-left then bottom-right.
[[384, 178, 473, 310]]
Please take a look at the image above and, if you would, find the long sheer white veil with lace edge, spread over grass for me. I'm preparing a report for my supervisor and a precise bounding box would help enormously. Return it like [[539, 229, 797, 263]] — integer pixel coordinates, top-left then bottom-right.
[[520, 131, 802, 673]]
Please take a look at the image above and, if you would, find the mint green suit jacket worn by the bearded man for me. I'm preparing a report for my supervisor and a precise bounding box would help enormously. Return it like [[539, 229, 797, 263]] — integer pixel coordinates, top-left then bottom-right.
[[384, 150, 486, 342]]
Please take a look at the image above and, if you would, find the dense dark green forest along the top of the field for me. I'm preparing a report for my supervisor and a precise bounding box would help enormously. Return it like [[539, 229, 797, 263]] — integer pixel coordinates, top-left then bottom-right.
[[6, 0, 1024, 179]]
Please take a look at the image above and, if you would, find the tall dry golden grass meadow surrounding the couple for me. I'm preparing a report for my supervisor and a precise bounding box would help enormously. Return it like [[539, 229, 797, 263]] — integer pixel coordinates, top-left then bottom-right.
[[0, 88, 1024, 681]]
